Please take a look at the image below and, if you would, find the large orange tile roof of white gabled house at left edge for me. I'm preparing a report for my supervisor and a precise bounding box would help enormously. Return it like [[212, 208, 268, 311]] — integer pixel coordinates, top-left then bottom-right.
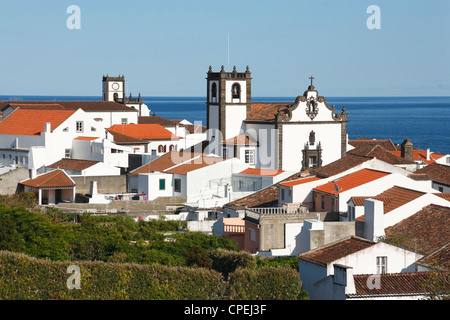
[[0, 108, 75, 136]]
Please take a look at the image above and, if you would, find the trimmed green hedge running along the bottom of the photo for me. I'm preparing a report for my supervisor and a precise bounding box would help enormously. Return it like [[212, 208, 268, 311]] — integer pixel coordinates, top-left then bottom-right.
[[0, 251, 304, 300]]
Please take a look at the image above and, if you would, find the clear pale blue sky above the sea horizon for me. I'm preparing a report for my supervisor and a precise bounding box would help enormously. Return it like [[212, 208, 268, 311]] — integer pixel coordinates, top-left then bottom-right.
[[0, 0, 450, 97]]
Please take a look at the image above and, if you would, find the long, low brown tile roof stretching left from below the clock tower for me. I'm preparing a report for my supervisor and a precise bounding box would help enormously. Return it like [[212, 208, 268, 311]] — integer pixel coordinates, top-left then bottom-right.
[[0, 101, 137, 112]]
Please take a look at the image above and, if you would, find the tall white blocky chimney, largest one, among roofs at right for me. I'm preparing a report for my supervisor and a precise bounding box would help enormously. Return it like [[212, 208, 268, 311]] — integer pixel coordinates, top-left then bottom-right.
[[364, 199, 385, 241]]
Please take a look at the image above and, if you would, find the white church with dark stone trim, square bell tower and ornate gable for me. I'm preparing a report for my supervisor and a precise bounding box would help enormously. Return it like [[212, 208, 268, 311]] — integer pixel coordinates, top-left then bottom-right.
[[206, 66, 348, 172]]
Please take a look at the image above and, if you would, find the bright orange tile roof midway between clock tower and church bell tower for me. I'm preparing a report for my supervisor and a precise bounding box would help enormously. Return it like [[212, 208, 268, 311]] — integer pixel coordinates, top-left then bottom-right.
[[107, 124, 178, 140]]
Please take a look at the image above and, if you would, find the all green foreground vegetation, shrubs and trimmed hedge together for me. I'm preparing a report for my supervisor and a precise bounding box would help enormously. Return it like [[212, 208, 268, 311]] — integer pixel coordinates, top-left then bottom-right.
[[0, 194, 307, 300]]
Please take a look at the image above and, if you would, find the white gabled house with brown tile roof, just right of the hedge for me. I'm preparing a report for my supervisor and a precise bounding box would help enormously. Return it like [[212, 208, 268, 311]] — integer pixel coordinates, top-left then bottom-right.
[[299, 236, 423, 300]]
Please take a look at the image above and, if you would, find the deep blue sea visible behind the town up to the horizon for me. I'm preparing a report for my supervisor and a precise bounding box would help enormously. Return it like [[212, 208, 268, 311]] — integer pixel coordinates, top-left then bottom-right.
[[0, 95, 450, 154]]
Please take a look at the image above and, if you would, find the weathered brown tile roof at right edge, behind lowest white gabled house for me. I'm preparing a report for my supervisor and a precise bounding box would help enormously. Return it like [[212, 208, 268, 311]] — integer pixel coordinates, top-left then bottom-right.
[[385, 204, 450, 254]]
